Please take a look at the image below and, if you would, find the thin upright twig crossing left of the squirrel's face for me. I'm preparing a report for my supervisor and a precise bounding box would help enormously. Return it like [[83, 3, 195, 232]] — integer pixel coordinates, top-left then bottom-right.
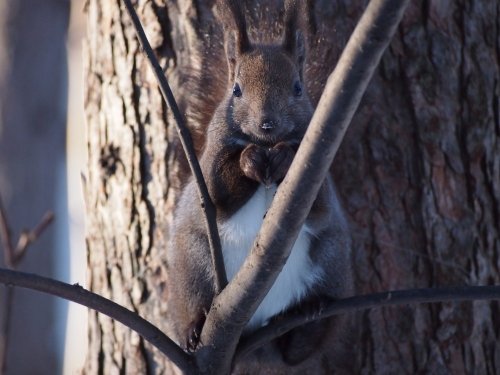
[[123, 0, 227, 294]]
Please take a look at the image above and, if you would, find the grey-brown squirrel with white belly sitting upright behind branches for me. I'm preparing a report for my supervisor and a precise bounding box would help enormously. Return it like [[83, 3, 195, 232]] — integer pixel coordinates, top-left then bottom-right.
[[167, 0, 352, 364]]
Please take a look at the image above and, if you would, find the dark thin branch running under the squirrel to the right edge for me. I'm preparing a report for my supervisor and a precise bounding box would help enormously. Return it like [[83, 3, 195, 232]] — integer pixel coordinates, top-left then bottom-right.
[[234, 286, 500, 361]]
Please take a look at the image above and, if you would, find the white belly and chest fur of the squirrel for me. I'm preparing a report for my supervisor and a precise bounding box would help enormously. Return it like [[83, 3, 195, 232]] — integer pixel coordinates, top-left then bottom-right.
[[219, 184, 322, 329]]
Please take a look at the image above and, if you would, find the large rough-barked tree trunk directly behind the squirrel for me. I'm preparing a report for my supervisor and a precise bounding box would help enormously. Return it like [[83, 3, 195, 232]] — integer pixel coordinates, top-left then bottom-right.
[[86, 0, 500, 373]]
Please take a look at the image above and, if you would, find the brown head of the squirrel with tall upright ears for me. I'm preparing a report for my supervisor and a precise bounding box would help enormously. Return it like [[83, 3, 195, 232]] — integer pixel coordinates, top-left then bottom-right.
[[216, 1, 313, 145]]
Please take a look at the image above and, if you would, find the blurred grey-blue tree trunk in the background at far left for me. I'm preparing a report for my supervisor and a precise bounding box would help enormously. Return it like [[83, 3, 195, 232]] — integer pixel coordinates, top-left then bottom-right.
[[0, 0, 70, 374]]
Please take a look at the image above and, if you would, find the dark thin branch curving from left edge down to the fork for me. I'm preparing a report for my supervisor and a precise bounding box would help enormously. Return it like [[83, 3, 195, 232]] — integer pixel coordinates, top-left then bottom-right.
[[0, 268, 194, 374]]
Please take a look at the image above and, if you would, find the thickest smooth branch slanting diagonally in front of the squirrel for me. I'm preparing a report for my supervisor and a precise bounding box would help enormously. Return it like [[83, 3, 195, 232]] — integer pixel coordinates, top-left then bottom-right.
[[197, 0, 409, 373]]
